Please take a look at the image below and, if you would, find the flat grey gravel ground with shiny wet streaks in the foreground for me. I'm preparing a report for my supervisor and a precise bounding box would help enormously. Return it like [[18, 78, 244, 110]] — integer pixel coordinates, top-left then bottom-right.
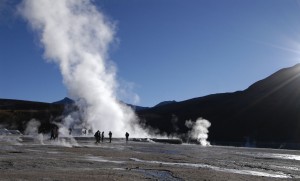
[[0, 137, 300, 181]]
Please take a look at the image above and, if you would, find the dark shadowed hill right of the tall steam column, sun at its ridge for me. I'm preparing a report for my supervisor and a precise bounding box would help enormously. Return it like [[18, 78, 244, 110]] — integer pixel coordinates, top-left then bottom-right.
[[137, 64, 300, 147]]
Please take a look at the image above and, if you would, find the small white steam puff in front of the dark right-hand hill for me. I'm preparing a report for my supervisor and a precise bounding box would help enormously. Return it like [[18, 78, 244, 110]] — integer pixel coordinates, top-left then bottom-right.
[[185, 118, 211, 146]]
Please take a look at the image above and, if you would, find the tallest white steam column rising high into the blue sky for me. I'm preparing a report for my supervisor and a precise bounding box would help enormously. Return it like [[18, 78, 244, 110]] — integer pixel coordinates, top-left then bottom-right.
[[19, 0, 146, 137]]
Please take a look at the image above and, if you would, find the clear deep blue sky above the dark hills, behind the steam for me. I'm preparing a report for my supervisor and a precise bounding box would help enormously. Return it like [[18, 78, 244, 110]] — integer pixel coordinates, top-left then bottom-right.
[[0, 0, 300, 106]]
